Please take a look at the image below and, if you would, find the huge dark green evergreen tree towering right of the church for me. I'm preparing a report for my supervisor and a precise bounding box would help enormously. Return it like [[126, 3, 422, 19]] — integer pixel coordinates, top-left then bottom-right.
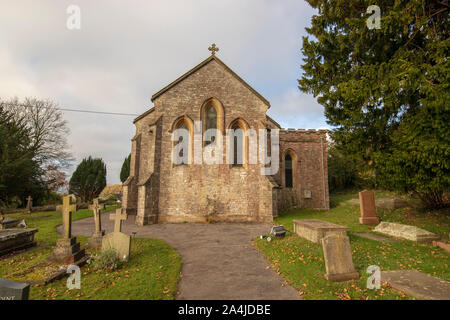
[[299, 0, 450, 207]]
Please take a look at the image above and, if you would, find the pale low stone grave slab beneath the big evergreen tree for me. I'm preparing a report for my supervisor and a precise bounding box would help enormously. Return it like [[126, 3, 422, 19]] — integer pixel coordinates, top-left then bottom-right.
[[373, 222, 439, 242]]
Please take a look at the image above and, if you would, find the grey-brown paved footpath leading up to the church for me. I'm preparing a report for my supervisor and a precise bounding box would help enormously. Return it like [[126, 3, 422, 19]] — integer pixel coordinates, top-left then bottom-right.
[[58, 213, 301, 300]]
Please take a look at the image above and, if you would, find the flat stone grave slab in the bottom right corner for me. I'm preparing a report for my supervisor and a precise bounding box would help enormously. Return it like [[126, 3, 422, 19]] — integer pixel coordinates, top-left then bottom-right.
[[381, 270, 450, 300]]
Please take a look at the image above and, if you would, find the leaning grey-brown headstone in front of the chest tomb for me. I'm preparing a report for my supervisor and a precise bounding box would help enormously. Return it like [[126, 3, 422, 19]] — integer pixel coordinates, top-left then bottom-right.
[[322, 234, 359, 282]]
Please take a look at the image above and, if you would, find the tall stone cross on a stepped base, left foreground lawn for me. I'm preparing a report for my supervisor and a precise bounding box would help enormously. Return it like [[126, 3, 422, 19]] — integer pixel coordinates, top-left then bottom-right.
[[49, 196, 86, 264]]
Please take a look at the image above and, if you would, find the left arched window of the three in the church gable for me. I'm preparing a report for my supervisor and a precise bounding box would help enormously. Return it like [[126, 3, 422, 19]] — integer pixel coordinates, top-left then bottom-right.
[[172, 117, 193, 165]]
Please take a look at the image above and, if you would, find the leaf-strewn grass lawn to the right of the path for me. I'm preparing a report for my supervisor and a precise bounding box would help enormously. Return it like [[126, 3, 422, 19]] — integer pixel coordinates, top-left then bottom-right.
[[254, 193, 450, 300]]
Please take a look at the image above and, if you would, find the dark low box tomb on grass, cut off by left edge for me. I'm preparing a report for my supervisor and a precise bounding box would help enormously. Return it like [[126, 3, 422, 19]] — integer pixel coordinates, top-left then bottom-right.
[[0, 229, 38, 256]]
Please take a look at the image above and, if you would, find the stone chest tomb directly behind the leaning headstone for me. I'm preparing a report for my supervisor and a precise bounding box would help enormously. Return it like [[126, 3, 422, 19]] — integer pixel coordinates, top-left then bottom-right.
[[292, 219, 347, 244]]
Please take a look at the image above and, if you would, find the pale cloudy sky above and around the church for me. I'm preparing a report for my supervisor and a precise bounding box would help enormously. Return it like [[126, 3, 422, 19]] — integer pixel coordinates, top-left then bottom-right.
[[0, 0, 327, 184]]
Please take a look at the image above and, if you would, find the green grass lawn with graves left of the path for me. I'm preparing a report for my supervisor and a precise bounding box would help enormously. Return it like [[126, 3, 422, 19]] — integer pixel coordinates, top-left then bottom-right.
[[0, 207, 181, 300]]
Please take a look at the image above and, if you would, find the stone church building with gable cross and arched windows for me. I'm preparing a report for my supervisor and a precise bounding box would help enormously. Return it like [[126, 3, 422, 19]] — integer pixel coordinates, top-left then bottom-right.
[[122, 45, 329, 226]]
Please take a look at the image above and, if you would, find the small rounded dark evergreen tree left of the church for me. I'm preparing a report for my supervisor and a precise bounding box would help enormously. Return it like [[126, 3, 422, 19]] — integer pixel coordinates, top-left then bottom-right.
[[69, 157, 106, 202]]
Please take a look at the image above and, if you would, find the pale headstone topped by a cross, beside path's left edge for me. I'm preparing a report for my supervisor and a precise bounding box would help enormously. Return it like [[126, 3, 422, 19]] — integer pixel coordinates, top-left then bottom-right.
[[102, 208, 131, 260]]
